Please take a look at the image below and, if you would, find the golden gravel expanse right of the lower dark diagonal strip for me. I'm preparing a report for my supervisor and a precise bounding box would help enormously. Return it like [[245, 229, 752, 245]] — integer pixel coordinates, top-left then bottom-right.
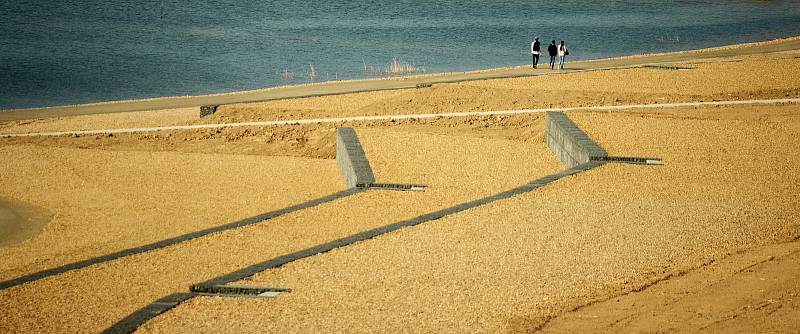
[[142, 106, 800, 333]]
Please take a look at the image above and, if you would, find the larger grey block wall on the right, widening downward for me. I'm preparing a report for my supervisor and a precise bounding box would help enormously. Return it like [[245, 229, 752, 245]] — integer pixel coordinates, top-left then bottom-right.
[[545, 112, 608, 168]]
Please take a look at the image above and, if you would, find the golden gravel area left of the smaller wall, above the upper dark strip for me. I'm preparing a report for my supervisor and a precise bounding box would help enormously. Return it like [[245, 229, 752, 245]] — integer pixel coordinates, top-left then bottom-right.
[[0, 147, 344, 280]]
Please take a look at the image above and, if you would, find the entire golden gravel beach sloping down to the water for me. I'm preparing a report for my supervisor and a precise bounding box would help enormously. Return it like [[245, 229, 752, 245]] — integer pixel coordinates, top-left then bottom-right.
[[0, 38, 800, 333]]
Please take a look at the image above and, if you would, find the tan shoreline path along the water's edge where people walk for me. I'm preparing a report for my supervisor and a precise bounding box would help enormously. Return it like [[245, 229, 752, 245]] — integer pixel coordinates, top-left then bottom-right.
[[0, 36, 800, 122]]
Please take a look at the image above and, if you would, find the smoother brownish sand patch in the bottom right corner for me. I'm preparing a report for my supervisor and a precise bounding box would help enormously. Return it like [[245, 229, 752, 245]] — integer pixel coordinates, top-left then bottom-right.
[[542, 241, 800, 333]]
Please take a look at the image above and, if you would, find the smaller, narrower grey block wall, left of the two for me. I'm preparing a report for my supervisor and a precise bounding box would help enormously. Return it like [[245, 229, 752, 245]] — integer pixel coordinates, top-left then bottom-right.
[[336, 127, 375, 188]]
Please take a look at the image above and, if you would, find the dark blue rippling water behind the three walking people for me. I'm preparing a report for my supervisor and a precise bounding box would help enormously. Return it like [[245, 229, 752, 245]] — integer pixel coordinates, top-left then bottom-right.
[[0, 0, 800, 109]]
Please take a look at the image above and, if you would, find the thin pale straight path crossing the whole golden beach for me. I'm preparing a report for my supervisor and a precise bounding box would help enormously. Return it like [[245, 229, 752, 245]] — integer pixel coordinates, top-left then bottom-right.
[[0, 98, 800, 137]]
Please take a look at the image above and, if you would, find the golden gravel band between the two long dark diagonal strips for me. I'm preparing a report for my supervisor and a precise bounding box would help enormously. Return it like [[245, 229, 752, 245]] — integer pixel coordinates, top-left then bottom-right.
[[0, 129, 562, 332]]
